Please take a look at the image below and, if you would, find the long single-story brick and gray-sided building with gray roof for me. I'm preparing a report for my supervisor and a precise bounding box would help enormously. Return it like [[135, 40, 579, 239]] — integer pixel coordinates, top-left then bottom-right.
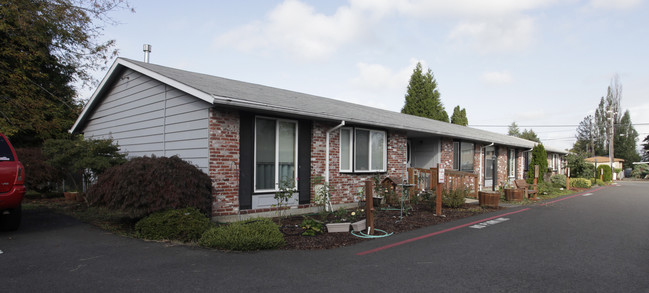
[[71, 58, 566, 221]]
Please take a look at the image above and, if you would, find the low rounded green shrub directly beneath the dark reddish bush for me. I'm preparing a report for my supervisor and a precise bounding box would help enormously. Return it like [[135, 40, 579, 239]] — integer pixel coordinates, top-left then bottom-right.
[[135, 208, 212, 242]]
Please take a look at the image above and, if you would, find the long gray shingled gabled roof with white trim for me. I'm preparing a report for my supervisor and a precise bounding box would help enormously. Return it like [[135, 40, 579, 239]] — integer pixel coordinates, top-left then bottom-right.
[[71, 58, 566, 153]]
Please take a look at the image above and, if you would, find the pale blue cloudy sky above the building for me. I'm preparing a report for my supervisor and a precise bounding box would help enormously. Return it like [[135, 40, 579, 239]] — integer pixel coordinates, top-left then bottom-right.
[[87, 0, 649, 148]]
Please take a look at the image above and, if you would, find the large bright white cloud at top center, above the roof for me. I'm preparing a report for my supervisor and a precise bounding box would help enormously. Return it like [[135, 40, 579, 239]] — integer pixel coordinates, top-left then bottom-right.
[[215, 0, 369, 59]]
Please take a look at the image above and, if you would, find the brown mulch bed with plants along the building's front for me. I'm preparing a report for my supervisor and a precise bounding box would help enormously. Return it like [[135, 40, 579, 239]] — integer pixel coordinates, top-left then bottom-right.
[[281, 203, 503, 250]]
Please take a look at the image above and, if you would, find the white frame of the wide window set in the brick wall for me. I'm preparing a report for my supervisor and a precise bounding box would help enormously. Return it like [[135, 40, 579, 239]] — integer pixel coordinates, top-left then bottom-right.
[[338, 127, 388, 173]]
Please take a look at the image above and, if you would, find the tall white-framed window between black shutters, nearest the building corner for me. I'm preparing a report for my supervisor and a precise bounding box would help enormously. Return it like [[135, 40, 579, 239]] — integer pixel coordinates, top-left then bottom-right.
[[255, 117, 297, 191]]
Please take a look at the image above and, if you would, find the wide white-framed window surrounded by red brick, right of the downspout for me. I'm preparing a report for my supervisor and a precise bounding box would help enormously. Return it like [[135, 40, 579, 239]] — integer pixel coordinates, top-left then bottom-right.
[[340, 128, 387, 172]]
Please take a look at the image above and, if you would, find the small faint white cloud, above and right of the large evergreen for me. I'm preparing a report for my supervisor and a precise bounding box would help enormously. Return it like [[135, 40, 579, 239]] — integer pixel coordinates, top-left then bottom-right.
[[448, 16, 535, 54]]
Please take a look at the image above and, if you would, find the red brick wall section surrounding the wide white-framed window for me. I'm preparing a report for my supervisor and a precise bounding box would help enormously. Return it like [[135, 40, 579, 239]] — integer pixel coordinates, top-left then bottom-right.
[[311, 122, 407, 205]]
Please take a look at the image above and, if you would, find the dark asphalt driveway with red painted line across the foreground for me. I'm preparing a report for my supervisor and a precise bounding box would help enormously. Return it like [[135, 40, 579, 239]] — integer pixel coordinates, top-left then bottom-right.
[[0, 182, 649, 292]]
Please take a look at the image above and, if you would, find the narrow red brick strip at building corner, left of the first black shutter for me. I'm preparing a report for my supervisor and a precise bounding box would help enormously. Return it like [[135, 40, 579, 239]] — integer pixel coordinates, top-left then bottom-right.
[[209, 108, 239, 216]]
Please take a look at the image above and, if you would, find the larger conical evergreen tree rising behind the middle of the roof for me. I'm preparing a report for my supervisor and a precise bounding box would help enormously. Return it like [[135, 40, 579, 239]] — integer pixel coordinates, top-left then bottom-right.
[[401, 62, 449, 122]]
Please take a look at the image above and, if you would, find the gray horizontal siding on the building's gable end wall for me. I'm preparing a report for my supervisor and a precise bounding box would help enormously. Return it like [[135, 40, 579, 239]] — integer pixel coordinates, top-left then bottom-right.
[[83, 69, 210, 173]]
